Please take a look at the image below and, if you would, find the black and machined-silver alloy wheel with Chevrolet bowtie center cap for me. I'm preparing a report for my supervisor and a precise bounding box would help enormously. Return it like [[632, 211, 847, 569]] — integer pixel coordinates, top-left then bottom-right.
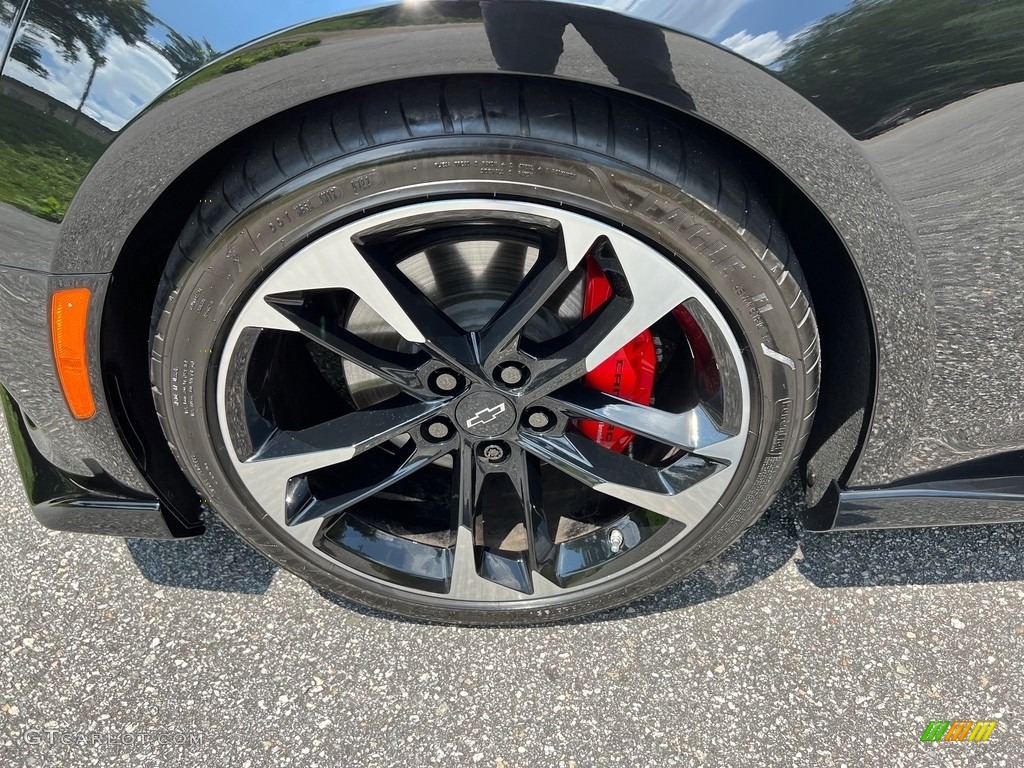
[[216, 200, 751, 604]]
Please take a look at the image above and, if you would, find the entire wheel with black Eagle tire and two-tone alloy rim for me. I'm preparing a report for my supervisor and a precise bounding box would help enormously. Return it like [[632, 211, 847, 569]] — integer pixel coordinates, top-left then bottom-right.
[[151, 77, 820, 625]]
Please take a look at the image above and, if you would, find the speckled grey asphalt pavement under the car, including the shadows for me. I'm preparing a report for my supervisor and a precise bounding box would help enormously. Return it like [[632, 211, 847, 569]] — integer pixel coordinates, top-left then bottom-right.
[[0, 415, 1024, 768]]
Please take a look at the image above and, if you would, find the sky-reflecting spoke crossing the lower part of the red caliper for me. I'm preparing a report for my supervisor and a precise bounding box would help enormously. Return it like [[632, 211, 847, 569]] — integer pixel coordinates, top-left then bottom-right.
[[548, 384, 746, 464]]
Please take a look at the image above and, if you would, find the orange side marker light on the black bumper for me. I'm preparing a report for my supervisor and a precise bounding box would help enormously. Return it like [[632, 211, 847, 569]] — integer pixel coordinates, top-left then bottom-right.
[[50, 288, 96, 419]]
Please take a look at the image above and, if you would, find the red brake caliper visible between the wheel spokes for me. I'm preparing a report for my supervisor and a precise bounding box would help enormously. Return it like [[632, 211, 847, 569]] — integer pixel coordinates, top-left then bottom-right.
[[580, 258, 657, 454]]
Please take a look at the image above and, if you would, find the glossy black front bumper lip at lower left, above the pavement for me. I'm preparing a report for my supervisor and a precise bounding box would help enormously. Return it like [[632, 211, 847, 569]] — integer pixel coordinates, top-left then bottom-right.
[[0, 387, 186, 539]]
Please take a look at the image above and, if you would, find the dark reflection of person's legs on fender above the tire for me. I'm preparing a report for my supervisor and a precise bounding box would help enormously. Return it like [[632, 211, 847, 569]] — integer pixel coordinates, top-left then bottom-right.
[[480, 0, 694, 111]]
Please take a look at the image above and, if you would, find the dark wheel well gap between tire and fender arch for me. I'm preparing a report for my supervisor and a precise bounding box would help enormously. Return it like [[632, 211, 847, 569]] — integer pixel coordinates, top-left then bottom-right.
[[100, 75, 874, 536]]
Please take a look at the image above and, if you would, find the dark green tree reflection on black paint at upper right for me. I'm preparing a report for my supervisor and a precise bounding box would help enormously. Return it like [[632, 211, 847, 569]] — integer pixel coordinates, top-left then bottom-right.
[[772, 0, 1024, 138]]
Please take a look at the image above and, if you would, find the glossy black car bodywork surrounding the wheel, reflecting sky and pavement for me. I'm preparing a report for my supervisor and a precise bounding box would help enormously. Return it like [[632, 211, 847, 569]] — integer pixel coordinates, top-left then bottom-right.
[[0, 0, 1024, 536]]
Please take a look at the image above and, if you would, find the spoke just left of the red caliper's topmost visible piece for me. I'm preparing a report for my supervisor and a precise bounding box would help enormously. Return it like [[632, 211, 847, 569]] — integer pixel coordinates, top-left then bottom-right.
[[478, 221, 598, 371]]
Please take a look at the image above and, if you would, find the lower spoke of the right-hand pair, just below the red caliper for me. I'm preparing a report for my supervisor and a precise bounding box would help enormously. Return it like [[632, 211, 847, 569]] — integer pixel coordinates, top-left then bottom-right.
[[520, 434, 731, 524]]
